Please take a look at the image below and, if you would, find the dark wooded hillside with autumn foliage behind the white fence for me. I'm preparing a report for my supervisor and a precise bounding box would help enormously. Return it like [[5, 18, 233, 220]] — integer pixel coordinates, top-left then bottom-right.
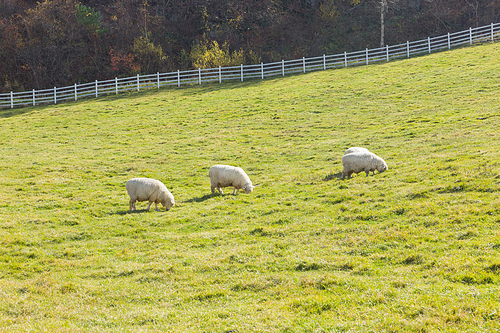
[[0, 0, 500, 92]]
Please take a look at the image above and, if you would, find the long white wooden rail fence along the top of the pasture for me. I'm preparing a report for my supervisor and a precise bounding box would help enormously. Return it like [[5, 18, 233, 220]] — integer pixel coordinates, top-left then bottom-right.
[[0, 23, 500, 108]]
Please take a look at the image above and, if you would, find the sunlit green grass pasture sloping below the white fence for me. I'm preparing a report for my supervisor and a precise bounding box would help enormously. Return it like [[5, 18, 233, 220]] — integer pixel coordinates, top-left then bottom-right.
[[0, 43, 500, 332]]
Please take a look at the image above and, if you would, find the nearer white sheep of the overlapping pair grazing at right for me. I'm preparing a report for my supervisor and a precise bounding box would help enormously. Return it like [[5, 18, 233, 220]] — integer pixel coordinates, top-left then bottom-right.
[[342, 152, 387, 178]]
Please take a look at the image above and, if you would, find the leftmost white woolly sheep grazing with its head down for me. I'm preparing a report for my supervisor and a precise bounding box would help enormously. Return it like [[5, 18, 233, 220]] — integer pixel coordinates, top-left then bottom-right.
[[125, 178, 175, 212]]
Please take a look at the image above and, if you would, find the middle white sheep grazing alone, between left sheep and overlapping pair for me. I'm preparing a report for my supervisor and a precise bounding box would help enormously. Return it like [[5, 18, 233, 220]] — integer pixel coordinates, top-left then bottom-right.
[[208, 164, 255, 195]]
